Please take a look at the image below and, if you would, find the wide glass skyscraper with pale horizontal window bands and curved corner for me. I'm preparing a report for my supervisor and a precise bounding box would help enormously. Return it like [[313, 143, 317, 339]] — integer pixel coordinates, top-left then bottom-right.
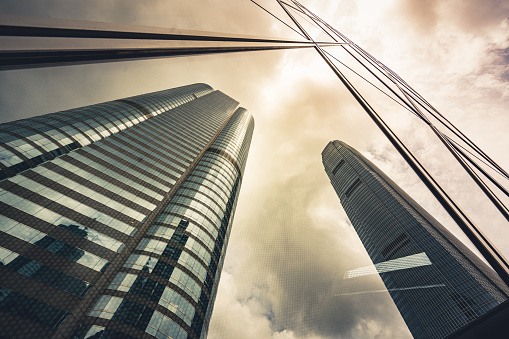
[[0, 84, 254, 339]]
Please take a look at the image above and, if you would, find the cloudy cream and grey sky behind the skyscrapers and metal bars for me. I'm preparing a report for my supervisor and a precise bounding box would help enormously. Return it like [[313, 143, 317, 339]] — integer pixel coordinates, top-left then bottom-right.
[[0, 0, 509, 339]]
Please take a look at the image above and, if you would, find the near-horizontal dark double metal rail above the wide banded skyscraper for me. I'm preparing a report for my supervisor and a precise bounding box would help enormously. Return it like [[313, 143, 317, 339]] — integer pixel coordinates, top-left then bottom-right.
[[0, 15, 346, 70]]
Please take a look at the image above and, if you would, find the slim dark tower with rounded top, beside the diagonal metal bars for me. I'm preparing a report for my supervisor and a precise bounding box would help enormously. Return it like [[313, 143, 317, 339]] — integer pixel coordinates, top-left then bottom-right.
[[322, 141, 509, 338]]
